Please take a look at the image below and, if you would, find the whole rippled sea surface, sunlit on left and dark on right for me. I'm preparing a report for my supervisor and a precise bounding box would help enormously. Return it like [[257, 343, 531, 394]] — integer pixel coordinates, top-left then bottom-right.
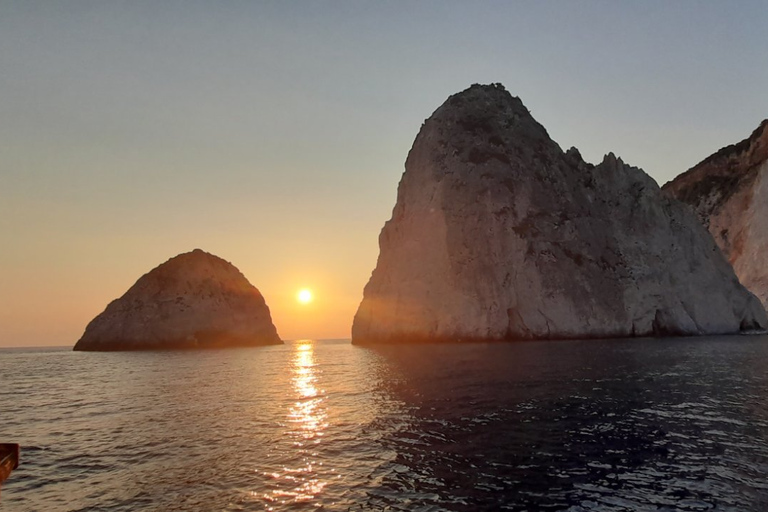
[[0, 337, 768, 511]]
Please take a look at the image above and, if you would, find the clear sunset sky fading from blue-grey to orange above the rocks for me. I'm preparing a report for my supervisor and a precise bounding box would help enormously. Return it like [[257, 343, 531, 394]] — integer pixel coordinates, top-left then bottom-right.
[[0, 0, 768, 347]]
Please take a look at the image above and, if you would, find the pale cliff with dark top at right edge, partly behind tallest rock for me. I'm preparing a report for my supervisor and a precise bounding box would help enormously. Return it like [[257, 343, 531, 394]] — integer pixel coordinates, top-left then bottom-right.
[[664, 119, 768, 307]]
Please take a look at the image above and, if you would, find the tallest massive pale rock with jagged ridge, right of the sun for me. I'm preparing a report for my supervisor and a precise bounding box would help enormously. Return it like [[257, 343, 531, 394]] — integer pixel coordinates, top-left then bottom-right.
[[352, 85, 766, 343]]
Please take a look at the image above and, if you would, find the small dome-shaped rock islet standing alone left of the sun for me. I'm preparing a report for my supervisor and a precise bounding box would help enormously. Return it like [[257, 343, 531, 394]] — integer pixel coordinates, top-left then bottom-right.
[[75, 249, 282, 350]]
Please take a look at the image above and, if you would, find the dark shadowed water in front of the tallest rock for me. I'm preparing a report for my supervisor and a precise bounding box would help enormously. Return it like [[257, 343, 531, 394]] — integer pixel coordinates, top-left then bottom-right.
[[369, 338, 768, 512]]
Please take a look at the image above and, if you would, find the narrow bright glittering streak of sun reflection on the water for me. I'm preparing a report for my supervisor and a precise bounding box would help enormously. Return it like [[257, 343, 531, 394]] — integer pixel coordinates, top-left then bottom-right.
[[264, 340, 328, 504]]
